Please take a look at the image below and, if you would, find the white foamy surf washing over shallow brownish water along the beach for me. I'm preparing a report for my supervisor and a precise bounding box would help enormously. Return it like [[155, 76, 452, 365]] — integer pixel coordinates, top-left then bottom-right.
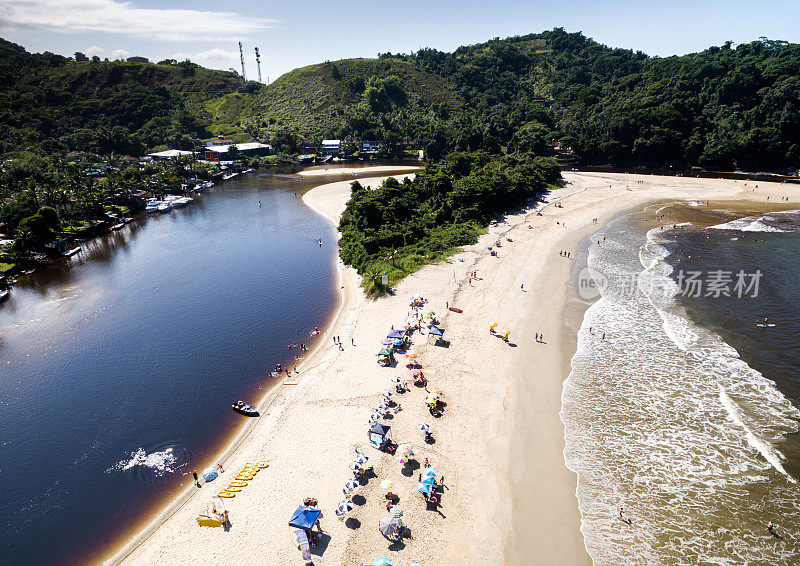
[[562, 215, 800, 565]]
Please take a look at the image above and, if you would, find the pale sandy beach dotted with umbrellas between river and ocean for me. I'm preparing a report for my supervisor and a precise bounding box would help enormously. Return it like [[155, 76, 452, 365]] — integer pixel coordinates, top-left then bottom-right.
[[111, 173, 800, 566]]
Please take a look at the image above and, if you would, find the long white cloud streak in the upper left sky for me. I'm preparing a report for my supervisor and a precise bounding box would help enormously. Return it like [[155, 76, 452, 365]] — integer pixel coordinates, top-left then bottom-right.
[[0, 0, 276, 41]]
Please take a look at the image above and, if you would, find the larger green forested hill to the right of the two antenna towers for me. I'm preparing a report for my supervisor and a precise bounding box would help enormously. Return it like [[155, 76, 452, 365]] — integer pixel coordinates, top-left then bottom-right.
[[242, 29, 800, 170]]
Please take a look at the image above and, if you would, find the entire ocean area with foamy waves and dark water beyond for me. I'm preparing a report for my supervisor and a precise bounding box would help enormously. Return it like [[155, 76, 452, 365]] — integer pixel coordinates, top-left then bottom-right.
[[562, 203, 800, 565]]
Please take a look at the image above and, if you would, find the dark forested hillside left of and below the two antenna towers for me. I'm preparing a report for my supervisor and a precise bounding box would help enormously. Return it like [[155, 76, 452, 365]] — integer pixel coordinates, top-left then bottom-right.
[[0, 39, 260, 155]]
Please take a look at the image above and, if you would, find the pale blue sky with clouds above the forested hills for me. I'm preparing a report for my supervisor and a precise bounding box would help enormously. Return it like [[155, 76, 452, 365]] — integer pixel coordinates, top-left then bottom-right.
[[0, 0, 800, 82]]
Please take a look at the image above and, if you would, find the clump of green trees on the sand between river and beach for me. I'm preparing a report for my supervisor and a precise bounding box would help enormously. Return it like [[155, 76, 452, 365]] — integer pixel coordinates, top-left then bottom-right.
[[339, 151, 561, 294]]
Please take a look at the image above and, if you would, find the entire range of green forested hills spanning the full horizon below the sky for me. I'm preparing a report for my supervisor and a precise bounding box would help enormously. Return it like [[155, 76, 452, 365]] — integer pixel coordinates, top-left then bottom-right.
[[0, 28, 800, 170]]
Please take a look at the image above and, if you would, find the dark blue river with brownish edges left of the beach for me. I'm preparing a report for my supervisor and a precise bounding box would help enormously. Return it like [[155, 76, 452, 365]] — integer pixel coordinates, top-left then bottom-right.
[[0, 169, 354, 564]]
